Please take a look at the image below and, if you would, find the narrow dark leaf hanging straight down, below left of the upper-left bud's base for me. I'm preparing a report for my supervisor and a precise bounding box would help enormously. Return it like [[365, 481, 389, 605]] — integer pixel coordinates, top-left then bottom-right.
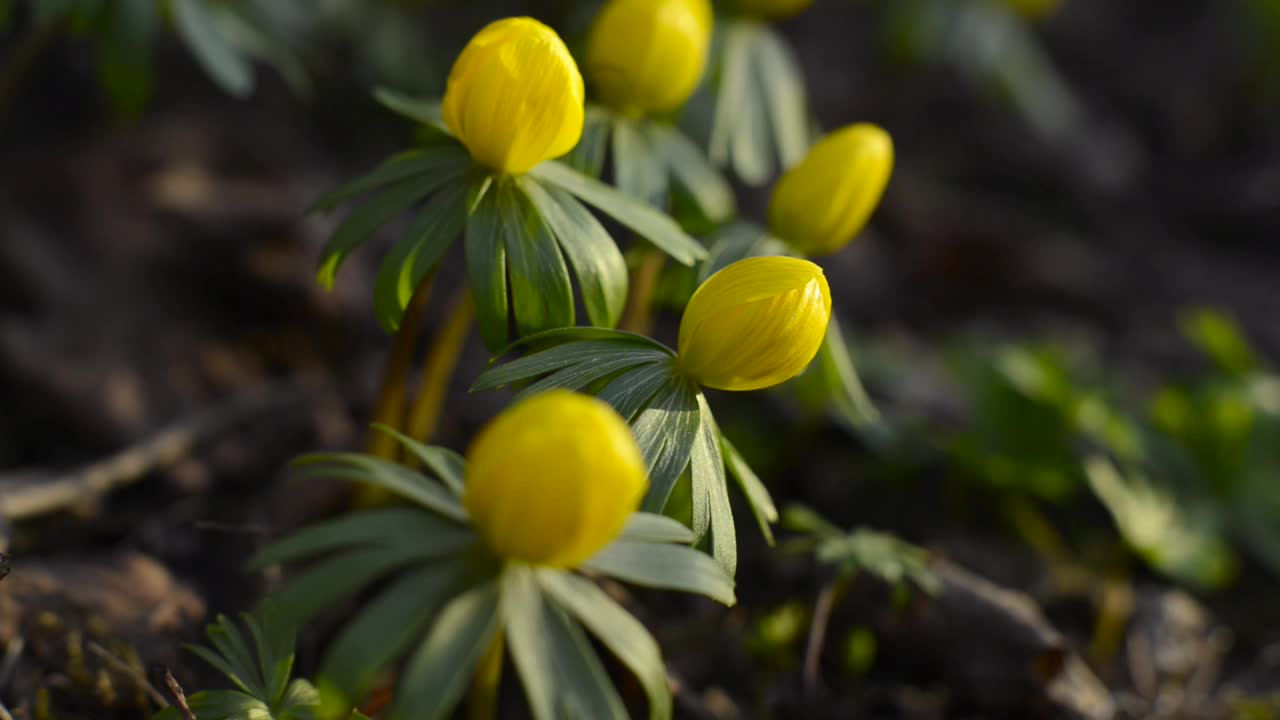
[[465, 178, 511, 352]]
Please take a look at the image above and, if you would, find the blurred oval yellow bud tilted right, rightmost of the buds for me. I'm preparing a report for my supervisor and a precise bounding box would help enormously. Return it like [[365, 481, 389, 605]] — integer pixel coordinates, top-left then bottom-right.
[[769, 123, 893, 255]]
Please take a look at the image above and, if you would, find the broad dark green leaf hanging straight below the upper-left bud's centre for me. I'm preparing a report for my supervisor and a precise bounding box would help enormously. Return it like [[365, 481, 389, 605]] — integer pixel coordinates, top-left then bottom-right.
[[498, 181, 575, 336]]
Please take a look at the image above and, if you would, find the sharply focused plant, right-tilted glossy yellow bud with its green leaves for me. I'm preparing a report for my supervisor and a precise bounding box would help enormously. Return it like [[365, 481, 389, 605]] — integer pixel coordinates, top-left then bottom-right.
[[472, 258, 831, 574]]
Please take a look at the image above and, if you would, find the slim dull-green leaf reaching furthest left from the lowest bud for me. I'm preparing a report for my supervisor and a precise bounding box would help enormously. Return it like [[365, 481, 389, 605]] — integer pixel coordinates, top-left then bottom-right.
[[248, 507, 476, 570]]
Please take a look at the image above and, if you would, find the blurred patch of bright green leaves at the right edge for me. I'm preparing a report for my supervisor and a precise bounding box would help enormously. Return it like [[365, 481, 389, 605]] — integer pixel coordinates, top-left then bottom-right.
[[943, 310, 1280, 588]]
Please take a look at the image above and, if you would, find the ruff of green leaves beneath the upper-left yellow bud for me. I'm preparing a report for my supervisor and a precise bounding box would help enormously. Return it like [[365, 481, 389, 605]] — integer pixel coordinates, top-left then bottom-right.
[[314, 91, 705, 351]]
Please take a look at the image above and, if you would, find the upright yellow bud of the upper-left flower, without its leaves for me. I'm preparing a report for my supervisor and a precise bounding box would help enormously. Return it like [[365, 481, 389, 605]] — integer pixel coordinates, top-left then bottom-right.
[[444, 18, 585, 174]]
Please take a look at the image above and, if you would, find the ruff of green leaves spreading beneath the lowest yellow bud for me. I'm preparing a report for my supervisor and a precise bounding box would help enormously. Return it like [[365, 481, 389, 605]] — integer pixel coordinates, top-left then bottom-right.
[[251, 430, 735, 720]]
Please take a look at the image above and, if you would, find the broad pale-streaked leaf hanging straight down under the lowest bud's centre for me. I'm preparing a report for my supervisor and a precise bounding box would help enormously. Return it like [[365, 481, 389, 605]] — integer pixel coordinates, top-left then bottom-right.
[[502, 566, 627, 720]]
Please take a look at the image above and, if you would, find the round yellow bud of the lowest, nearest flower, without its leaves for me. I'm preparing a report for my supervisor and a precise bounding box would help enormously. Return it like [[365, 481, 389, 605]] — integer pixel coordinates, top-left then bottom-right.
[[463, 389, 649, 568]]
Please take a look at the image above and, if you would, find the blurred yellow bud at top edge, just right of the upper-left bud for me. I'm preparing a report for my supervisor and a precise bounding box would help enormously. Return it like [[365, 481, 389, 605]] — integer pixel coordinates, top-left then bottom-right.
[[586, 0, 713, 114]]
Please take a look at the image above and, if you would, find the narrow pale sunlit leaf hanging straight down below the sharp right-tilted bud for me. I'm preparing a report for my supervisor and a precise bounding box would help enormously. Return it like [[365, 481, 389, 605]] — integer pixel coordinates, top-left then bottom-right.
[[689, 393, 737, 578]]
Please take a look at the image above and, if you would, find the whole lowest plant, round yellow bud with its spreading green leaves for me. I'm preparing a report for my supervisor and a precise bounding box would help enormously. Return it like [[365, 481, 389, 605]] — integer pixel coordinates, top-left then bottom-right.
[[253, 389, 733, 720]]
